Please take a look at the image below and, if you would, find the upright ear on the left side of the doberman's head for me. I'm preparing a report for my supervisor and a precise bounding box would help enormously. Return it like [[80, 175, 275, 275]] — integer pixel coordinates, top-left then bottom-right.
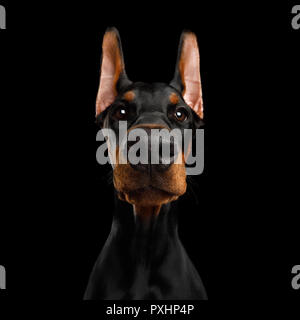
[[96, 28, 131, 116]]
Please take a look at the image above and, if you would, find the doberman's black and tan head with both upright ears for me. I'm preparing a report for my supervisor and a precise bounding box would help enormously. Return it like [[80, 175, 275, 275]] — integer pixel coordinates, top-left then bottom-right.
[[96, 29, 203, 212]]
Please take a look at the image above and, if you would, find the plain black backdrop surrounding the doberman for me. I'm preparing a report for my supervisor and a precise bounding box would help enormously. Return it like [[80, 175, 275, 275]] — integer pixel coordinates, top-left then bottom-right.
[[0, 1, 299, 301]]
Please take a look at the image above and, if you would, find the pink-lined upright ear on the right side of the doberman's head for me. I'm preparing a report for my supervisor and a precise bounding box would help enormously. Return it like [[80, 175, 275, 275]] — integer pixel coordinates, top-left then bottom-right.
[[170, 31, 203, 119]]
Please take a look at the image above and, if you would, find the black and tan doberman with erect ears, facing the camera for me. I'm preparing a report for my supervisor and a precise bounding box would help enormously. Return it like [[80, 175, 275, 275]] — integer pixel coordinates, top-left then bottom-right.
[[84, 28, 207, 300]]
